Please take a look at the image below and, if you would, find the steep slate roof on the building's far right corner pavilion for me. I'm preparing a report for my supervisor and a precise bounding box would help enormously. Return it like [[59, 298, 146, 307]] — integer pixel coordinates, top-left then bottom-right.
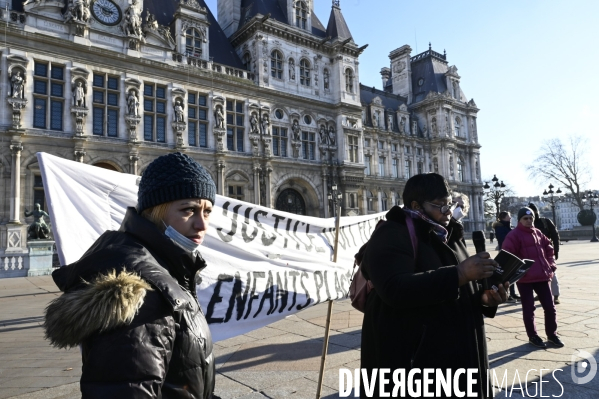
[[411, 47, 448, 102]]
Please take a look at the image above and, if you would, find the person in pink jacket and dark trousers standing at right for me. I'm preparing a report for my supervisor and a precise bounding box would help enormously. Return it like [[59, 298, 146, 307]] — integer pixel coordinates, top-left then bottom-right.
[[501, 208, 564, 348]]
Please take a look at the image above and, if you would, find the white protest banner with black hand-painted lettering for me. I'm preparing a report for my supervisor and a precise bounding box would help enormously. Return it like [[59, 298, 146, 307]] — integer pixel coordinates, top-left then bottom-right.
[[38, 153, 384, 341]]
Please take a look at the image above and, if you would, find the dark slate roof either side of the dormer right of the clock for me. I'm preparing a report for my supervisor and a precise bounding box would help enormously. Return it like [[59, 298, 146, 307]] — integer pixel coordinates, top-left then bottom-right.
[[147, 0, 243, 69]]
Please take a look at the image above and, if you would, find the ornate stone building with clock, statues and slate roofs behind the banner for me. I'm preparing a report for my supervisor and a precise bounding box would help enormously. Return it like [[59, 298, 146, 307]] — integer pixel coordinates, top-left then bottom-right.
[[0, 0, 482, 260]]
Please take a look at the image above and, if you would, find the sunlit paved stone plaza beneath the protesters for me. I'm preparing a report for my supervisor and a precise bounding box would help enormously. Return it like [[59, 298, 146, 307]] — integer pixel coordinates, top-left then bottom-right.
[[0, 241, 599, 399]]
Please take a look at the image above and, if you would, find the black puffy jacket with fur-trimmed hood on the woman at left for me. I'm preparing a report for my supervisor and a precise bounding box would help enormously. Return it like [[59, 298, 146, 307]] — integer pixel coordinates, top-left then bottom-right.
[[44, 208, 215, 399]]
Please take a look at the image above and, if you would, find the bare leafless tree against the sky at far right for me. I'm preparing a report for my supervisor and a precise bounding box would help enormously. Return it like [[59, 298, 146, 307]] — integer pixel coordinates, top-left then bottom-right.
[[526, 136, 590, 210]]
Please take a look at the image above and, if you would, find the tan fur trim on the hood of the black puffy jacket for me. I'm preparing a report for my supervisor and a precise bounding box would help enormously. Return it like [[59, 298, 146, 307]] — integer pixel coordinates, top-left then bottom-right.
[[44, 269, 152, 348]]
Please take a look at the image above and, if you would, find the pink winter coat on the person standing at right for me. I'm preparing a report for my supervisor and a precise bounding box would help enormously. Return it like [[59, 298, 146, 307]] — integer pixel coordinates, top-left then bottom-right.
[[501, 223, 556, 283]]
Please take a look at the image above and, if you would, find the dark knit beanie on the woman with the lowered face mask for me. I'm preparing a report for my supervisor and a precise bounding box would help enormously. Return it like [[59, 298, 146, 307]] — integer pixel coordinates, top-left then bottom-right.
[[137, 152, 216, 214]]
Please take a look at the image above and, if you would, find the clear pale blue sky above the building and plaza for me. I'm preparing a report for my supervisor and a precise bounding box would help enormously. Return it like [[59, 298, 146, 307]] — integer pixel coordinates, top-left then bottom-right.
[[206, 0, 599, 196]]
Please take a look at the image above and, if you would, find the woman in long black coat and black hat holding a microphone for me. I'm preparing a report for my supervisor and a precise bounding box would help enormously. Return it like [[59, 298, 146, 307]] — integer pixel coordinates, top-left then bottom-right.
[[361, 173, 506, 397]]
